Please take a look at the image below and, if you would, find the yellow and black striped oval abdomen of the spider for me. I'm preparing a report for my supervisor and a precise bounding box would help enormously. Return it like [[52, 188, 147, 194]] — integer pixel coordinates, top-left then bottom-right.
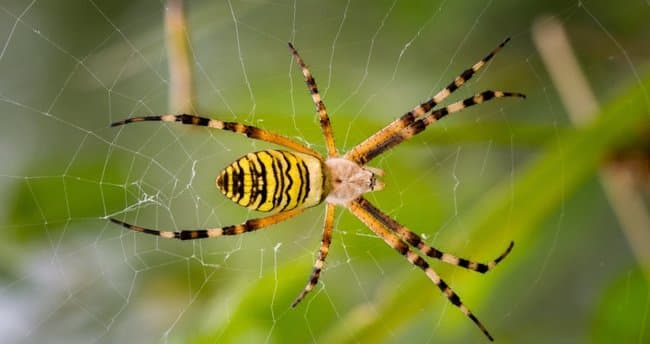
[[217, 149, 324, 212]]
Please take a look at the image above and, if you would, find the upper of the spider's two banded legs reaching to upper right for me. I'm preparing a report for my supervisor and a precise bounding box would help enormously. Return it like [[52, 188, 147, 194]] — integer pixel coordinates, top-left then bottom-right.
[[345, 38, 510, 165]]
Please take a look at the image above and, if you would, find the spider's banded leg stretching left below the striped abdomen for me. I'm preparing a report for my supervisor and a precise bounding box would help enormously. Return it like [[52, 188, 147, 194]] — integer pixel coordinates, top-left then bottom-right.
[[110, 208, 305, 240]]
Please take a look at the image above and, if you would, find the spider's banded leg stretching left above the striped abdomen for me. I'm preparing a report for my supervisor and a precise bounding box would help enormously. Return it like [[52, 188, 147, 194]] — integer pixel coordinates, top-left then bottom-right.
[[111, 114, 321, 158]]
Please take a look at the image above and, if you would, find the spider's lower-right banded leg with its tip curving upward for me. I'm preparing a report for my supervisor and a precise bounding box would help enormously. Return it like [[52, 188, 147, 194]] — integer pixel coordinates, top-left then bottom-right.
[[350, 195, 514, 273]]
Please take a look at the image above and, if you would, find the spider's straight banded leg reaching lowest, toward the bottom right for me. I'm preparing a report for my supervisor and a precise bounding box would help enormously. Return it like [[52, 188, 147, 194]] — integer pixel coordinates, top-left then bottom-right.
[[347, 197, 494, 341]]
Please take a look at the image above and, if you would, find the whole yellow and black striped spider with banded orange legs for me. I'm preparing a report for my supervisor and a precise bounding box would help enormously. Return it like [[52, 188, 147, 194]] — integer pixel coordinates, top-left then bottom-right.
[[110, 38, 525, 341]]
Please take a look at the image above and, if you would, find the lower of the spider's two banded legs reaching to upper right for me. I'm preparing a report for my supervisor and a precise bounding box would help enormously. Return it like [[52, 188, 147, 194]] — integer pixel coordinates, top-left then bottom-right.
[[358, 91, 526, 162]]
